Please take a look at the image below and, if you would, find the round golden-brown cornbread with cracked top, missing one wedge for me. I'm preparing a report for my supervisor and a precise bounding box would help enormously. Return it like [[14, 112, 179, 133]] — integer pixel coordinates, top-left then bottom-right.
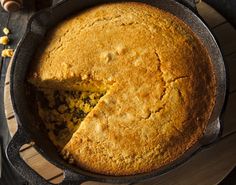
[[28, 2, 216, 176]]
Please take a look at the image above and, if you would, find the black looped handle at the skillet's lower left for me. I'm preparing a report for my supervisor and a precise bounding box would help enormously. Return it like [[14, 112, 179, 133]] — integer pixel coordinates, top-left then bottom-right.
[[6, 125, 88, 185]]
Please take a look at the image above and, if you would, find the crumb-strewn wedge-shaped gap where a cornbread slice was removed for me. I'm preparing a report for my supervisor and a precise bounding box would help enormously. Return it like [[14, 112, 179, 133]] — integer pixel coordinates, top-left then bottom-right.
[[36, 88, 105, 150]]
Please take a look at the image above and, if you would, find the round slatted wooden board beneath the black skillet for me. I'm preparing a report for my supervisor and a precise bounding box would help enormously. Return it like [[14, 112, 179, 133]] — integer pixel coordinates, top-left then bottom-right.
[[0, 3, 236, 185]]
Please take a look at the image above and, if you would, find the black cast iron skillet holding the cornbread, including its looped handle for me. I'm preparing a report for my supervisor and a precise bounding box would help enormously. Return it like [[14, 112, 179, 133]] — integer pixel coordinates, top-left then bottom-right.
[[6, 0, 226, 185]]
